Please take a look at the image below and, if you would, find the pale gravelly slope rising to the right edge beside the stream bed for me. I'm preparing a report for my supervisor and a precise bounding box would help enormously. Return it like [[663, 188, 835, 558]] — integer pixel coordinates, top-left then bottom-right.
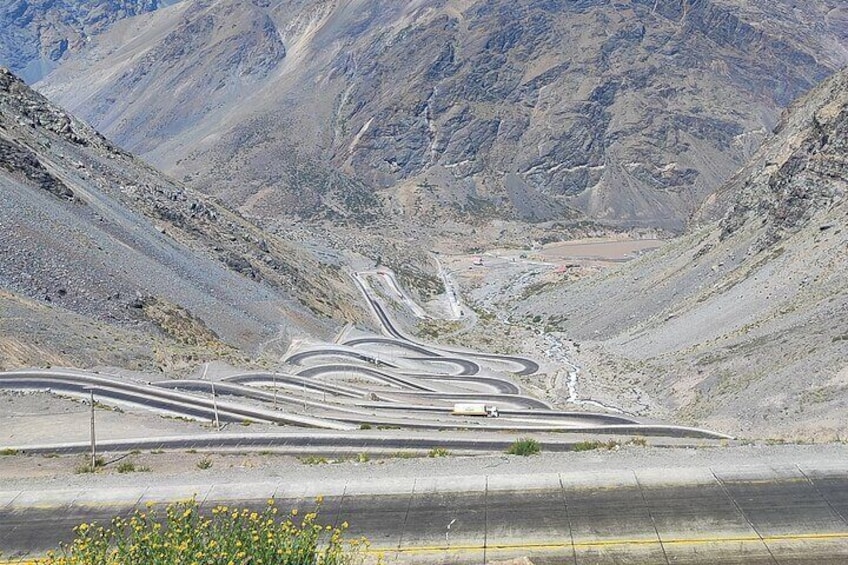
[[515, 67, 848, 439]]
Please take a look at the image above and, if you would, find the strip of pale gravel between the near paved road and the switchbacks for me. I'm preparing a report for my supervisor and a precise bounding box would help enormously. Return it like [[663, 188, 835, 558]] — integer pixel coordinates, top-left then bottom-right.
[[0, 443, 848, 490]]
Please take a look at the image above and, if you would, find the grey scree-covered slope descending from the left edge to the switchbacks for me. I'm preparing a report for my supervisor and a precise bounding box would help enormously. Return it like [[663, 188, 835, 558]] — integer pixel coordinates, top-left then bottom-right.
[[0, 70, 359, 366]]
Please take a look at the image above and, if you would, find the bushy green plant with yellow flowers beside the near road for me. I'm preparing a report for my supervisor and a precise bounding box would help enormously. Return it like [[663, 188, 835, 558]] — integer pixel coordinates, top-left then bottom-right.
[[38, 498, 369, 565]]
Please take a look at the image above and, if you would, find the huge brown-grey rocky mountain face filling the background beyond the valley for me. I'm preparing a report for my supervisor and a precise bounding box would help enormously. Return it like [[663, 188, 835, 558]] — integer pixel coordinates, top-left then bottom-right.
[[39, 0, 848, 229]]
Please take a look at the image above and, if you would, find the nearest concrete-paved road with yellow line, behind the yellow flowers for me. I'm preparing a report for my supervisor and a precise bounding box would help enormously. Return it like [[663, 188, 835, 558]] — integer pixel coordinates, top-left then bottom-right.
[[0, 467, 848, 565]]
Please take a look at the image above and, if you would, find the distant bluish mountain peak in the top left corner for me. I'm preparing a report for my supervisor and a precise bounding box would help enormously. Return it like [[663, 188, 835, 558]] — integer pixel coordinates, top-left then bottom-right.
[[0, 0, 173, 83]]
